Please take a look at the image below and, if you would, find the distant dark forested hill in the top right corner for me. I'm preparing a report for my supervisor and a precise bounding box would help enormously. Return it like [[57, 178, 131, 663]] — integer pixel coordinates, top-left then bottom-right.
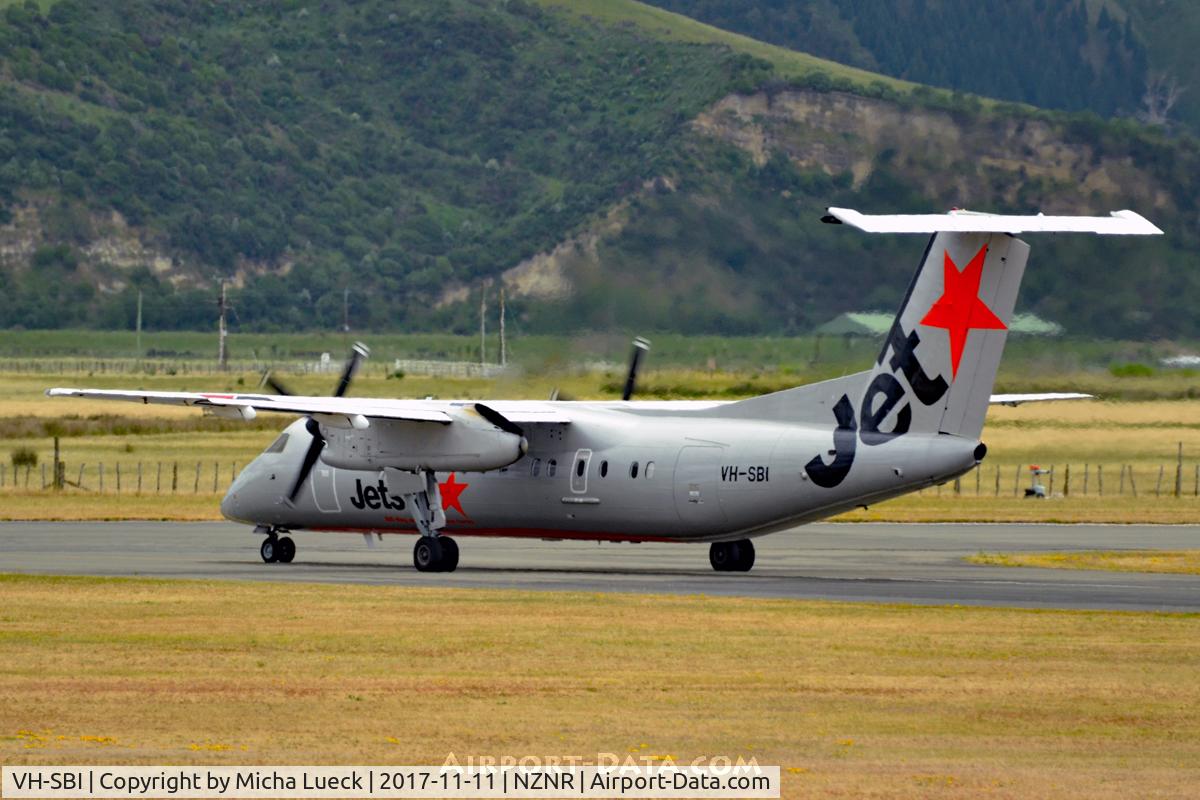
[[648, 0, 1200, 130]]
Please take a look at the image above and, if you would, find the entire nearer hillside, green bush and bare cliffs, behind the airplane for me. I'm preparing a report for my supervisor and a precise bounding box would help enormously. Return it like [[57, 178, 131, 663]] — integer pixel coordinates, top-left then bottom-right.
[[0, 0, 1200, 337]]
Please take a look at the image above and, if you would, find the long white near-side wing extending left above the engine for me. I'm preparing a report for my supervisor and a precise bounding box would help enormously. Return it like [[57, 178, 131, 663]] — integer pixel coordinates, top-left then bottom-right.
[[46, 389, 570, 427]]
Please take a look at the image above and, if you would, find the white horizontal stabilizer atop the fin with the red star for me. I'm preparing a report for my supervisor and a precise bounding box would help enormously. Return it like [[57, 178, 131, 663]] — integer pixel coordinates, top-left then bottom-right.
[[822, 207, 1163, 236]]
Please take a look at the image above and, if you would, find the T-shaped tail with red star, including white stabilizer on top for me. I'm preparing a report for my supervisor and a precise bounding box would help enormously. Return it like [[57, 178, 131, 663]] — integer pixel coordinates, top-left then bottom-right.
[[826, 209, 1162, 444]]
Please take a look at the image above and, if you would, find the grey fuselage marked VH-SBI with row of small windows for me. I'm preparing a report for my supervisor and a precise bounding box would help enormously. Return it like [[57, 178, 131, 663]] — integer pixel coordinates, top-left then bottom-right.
[[221, 403, 978, 541]]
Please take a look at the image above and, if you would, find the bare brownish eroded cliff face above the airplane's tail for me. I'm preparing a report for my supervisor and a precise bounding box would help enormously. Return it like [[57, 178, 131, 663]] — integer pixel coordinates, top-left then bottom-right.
[[694, 91, 1174, 213]]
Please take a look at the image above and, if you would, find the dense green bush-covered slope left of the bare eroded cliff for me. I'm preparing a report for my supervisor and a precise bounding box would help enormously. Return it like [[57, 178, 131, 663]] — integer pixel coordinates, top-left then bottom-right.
[[0, 0, 764, 326]]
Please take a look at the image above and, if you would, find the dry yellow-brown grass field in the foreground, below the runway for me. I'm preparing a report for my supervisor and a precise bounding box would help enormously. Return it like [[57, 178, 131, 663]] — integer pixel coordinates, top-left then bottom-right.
[[0, 576, 1200, 799]]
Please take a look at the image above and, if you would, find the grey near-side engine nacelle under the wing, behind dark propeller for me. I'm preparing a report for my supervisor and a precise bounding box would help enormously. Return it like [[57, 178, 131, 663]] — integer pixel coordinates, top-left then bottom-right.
[[320, 408, 528, 471]]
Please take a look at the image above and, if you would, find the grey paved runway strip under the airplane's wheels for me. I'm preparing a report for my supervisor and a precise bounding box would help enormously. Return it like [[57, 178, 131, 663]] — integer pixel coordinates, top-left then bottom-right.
[[0, 523, 1200, 612]]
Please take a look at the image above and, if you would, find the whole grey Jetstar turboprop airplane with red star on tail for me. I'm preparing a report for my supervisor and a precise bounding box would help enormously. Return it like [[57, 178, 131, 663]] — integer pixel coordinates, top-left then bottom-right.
[[47, 209, 1162, 572]]
